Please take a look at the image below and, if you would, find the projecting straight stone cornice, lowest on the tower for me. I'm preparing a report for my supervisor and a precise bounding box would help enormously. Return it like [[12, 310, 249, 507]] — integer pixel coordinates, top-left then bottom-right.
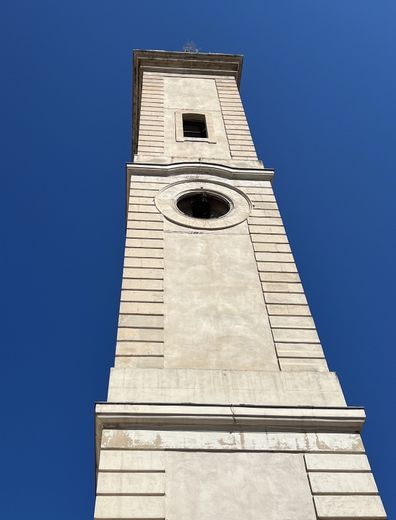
[[95, 403, 366, 464]]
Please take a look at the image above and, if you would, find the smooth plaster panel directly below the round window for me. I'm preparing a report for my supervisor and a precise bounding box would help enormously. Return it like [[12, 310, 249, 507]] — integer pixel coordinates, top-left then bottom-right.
[[164, 232, 278, 370]]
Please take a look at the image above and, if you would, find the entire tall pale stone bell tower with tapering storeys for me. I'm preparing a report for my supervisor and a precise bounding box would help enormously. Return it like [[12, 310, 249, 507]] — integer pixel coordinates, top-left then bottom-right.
[[95, 51, 386, 520]]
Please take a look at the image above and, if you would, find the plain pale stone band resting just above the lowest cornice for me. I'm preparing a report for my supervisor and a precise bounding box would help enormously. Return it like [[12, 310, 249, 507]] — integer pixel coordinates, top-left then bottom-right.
[[108, 368, 345, 406]]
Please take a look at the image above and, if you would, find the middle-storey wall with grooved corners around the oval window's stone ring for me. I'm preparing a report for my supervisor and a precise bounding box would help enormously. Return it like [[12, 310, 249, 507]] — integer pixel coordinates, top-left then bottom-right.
[[116, 176, 327, 371]]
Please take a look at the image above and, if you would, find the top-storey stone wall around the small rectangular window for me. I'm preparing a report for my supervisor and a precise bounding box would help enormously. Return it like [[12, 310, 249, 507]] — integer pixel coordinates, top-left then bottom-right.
[[135, 72, 260, 167]]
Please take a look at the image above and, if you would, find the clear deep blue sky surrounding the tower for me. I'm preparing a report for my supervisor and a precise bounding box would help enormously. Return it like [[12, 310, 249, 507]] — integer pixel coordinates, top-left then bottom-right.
[[0, 0, 396, 520]]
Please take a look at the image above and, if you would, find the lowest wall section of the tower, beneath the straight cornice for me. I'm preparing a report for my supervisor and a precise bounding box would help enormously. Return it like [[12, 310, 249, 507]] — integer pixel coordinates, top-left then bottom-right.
[[95, 410, 386, 520]]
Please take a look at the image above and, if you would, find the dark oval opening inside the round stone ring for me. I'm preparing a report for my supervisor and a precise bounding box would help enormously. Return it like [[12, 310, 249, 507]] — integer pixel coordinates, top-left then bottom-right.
[[177, 191, 231, 219]]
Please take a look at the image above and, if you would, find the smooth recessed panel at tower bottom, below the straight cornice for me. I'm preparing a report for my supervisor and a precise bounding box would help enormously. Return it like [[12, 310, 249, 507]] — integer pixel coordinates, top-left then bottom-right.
[[166, 452, 316, 520]]
